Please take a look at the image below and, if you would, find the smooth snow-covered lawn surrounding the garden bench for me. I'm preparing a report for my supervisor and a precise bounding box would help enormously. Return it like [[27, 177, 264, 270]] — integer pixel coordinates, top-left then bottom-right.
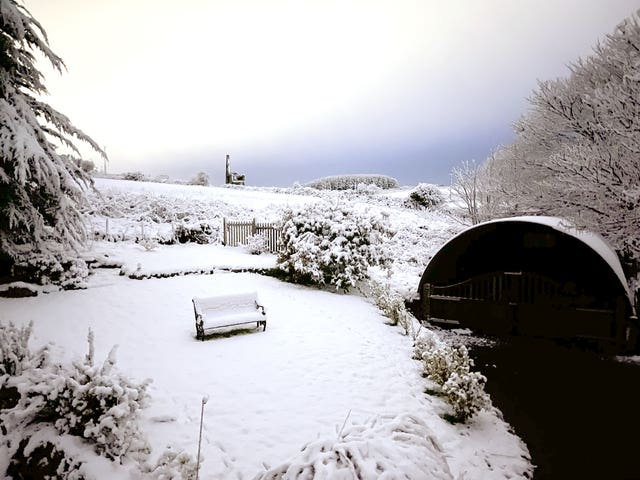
[[0, 270, 527, 479]]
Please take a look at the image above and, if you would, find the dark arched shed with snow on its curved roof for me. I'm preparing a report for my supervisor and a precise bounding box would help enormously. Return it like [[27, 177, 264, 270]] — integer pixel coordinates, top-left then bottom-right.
[[417, 217, 637, 349]]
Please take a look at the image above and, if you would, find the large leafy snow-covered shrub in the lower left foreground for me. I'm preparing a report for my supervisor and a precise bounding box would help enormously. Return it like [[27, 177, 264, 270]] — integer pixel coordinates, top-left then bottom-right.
[[0, 332, 149, 459]]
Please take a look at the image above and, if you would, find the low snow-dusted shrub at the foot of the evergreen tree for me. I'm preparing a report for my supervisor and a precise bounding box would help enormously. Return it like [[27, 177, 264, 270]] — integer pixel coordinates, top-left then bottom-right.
[[12, 251, 89, 290]]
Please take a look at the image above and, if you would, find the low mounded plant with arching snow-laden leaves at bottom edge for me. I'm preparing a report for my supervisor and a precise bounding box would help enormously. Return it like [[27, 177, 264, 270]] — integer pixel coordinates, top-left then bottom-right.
[[255, 414, 453, 480]]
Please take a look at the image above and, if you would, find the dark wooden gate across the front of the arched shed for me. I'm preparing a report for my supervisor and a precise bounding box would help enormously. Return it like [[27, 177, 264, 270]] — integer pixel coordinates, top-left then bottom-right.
[[421, 272, 629, 346]]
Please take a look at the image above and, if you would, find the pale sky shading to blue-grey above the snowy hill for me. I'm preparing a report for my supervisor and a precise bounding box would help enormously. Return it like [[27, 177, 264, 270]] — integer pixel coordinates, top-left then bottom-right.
[[24, 0, 638, 186]]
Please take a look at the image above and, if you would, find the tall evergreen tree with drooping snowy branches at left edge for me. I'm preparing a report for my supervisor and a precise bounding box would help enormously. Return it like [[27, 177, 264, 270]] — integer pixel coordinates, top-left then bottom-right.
[[0, 0, 105, 270]]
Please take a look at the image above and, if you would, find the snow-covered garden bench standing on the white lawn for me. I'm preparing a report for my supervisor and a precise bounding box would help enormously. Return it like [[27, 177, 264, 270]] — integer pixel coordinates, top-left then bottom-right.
[[192, 292, 267, 340]]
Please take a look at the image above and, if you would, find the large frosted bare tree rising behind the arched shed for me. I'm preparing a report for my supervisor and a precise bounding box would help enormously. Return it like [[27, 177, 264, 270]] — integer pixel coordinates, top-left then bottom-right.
[[487, 9, 640, 255]]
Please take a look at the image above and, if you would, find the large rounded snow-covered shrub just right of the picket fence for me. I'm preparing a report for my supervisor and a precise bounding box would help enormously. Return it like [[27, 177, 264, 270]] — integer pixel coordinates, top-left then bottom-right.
[[277, 202, 389, 290]]
